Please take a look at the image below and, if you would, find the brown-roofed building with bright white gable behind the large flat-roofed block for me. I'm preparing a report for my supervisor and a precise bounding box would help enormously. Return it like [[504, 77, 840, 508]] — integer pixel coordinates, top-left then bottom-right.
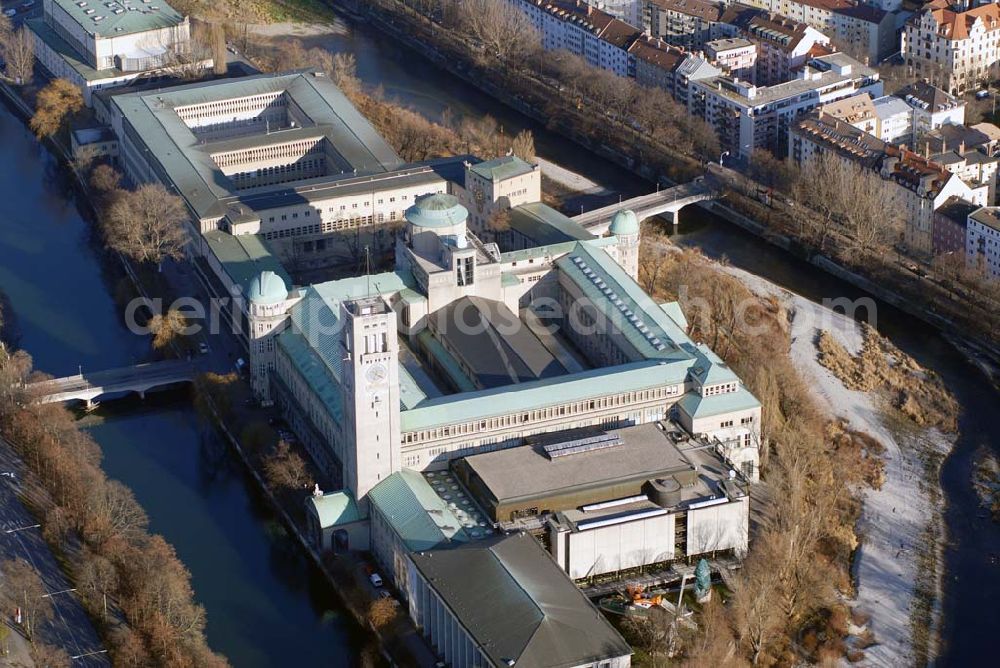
[[745, 14, 833, 86]]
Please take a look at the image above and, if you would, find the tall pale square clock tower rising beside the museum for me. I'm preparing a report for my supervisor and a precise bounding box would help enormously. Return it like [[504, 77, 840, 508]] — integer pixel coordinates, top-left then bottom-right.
[[341, 296, 402, 502]]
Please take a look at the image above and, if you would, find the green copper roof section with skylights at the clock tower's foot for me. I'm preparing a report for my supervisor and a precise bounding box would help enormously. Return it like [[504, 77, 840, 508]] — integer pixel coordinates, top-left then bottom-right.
[[367, 469, 469, 552]]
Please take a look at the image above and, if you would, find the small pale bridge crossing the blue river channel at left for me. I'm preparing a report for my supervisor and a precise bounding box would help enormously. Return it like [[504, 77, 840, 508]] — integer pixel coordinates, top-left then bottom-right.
[[27, 360, 203, 408]]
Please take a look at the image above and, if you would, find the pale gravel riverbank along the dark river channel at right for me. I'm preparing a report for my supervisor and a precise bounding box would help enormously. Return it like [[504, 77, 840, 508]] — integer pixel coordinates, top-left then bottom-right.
[[725, 267, 953, 665]]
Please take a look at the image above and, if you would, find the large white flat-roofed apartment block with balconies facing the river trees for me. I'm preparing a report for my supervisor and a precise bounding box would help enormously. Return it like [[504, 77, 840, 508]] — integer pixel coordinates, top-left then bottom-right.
[[689, 53, 882, 160]]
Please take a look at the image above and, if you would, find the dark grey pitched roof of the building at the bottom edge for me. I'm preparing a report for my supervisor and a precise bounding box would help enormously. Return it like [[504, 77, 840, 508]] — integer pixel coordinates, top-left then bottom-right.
[[410, 533, 632, 668]]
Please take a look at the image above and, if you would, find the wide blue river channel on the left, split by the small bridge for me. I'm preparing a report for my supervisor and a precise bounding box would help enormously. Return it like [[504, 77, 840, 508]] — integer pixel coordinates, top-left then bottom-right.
[[0, 105, 362, 668]]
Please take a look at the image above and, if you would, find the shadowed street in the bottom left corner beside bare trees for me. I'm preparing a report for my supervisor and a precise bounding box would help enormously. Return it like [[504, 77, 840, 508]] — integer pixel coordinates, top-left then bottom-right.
[[0, 439, 111, 666]]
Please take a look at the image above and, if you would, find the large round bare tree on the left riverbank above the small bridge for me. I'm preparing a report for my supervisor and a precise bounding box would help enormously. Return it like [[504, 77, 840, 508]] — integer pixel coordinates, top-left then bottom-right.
[[104, 183, 188, 268]]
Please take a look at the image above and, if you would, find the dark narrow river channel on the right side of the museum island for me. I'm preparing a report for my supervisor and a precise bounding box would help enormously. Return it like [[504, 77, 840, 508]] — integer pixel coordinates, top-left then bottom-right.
[[307, 11, 1000, 665]]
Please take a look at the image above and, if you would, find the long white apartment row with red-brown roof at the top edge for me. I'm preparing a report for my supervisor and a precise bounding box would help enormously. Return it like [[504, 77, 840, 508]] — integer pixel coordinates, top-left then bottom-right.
[[506, 0, 640, 77]]
